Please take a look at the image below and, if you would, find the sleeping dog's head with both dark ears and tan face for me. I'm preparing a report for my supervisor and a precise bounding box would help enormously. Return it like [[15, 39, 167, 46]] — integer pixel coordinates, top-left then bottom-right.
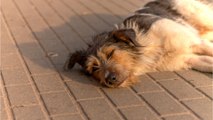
[[65, 29, 140, 87]]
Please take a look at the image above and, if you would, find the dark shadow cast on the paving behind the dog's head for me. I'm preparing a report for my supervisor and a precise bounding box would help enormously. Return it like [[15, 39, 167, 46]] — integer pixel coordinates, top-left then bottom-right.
[[19, 14, 122, 86]]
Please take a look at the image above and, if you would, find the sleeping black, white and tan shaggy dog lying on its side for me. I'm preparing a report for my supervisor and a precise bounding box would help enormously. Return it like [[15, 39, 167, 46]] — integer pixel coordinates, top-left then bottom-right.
[[64, 0, 213, 88]]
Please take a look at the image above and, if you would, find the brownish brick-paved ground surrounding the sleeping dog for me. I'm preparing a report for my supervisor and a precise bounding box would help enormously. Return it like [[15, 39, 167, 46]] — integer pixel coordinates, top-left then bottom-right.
[[0, 0, 213, 120]]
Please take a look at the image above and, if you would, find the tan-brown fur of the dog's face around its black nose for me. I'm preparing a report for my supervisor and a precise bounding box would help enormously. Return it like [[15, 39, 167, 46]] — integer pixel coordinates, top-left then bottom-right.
[[86, 40, 136, 87]]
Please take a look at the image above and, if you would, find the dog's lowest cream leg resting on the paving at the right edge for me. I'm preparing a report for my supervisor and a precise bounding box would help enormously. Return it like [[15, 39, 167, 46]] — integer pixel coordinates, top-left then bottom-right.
[[187, 55, 213, 72]]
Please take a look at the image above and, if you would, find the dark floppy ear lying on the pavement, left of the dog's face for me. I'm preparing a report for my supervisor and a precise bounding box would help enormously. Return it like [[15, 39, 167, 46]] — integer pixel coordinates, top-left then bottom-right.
[[64, 51, 86, 70]]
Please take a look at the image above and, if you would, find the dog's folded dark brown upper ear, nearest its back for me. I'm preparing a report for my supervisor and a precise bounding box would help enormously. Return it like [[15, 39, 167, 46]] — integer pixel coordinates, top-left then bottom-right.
[[112, 29, 140, 47]]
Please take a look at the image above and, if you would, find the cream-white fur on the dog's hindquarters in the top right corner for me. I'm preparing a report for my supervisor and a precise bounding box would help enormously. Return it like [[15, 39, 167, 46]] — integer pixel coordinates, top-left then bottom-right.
[[171, 0, 213, 30]]
